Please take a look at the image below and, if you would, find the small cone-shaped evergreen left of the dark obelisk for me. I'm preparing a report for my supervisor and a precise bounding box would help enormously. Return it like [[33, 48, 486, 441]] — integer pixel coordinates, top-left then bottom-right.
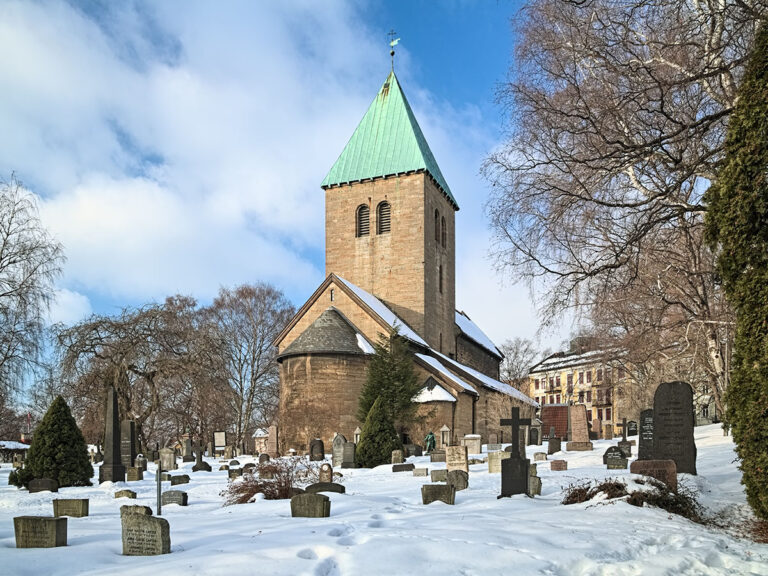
[[9, 396, 93, 487]]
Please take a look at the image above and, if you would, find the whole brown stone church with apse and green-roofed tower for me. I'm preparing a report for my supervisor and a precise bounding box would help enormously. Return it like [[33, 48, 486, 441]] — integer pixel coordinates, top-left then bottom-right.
[[275, 71, 536, 453]]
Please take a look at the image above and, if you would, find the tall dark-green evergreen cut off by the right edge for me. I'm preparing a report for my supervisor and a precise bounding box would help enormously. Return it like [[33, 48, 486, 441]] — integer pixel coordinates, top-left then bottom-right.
[[706, 25, 768, 519]]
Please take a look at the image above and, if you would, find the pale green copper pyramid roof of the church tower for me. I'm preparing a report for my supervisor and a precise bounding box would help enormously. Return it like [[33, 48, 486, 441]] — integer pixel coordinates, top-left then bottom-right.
[[321, 71, 459, 210]]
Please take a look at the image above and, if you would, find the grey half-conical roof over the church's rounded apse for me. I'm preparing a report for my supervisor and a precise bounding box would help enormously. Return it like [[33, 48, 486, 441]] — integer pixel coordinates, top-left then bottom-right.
[[278, 306, 373, 360]]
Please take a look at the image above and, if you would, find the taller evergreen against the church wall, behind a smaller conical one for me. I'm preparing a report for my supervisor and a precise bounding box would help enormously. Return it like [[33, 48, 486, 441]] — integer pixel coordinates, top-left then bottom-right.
[[357, 329, 419, 427]]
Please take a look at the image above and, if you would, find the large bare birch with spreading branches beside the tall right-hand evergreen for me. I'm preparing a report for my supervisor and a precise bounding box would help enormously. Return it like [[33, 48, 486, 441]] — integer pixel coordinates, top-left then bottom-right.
[[484, 0, 766, 414]]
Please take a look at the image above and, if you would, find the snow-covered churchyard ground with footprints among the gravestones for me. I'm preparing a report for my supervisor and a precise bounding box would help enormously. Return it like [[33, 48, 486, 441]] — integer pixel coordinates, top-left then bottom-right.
[[0, 425, 768, 576]]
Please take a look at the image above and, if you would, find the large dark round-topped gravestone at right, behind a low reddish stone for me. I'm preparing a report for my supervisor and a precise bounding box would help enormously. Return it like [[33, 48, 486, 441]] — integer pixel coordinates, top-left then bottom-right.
[[653, 382, 696, 474]]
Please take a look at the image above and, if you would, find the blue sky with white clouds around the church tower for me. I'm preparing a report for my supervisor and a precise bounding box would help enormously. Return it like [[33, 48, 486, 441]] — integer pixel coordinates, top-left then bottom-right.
[[0, 0, 569, 346]]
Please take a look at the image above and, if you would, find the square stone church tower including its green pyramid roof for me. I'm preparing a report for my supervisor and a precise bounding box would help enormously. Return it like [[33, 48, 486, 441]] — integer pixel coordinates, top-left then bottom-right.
[[322, 71, 459, 357]]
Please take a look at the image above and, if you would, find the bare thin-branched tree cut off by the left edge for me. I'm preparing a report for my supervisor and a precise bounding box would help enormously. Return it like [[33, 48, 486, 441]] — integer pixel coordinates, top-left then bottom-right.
[[0, 178, 64, 394]]
